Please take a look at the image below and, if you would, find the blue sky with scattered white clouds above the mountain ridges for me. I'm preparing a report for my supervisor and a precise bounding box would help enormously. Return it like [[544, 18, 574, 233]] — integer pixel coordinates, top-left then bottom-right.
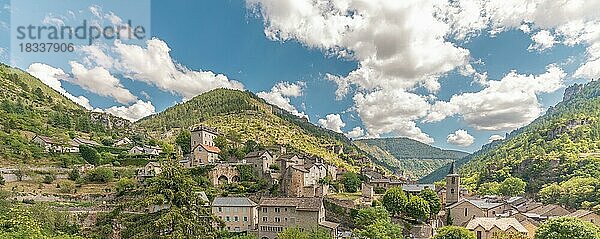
[[0, 0, 598, 152]]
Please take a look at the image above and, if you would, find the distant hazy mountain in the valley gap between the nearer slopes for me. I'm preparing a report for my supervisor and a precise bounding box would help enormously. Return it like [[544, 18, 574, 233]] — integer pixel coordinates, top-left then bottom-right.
[[354, 138, 469, 179]]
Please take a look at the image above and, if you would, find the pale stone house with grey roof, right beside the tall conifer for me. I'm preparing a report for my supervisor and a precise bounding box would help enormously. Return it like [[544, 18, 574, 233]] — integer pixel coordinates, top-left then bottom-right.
[[212, 197, 258, 232]]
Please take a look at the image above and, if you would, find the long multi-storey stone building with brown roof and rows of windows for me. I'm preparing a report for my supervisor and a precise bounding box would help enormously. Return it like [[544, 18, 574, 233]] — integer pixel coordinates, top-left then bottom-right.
[[258, 198, 338, 239]]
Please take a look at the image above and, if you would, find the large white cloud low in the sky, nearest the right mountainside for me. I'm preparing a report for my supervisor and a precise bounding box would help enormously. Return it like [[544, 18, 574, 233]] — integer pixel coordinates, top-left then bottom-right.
[[424, 65, 566, 130]]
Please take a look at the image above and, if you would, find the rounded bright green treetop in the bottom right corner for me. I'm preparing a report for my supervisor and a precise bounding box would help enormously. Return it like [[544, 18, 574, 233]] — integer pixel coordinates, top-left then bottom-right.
[[535, 217, 600, 239]]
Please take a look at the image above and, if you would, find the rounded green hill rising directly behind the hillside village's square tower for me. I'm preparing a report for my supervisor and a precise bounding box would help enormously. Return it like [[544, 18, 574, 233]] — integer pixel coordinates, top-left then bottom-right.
[[136, 89, 357, 167]]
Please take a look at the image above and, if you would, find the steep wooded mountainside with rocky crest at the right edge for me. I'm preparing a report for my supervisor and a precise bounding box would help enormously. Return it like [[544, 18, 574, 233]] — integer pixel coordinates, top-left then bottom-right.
[[426, 81, 600, 193]]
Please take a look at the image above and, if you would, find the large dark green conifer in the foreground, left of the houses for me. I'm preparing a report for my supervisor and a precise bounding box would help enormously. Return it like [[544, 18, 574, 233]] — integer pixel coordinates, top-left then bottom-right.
[[121, 161, 220, 238]]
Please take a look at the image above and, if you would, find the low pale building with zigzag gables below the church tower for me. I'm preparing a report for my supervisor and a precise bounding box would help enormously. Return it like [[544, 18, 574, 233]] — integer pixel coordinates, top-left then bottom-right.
[[466, 217, 529, 239]]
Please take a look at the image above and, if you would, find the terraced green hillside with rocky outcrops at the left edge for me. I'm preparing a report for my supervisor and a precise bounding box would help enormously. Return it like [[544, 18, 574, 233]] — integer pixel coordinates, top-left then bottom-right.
[[0, 64, 130, 165]]
